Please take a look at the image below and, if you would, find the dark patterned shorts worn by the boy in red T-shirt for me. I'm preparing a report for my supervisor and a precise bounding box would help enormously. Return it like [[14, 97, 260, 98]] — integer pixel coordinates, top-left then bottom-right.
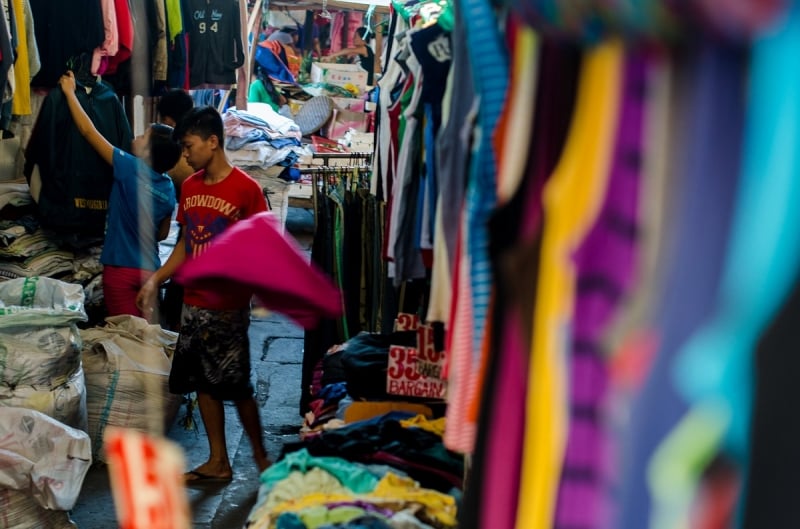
[[169, 305, 253, 400]]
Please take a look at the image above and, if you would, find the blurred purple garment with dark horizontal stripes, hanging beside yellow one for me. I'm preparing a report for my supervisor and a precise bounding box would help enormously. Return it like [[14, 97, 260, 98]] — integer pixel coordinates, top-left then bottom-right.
[[554, 51, 647, 529]]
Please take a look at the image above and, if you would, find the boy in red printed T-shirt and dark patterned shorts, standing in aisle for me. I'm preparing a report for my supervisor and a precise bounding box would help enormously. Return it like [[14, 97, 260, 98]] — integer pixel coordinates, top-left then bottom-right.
[[137, 107, 270, 484]]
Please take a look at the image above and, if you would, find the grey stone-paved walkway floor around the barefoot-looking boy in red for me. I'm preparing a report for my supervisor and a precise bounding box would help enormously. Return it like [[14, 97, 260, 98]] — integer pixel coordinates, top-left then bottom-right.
[[71, 208, 313, 529]]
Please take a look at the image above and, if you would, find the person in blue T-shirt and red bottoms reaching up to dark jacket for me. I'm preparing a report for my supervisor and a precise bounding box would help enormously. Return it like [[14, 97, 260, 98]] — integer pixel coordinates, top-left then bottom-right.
[[58, 71, 181, 321]]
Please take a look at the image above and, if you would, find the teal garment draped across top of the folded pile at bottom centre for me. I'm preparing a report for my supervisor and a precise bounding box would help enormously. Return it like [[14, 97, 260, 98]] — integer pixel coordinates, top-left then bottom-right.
[[260, 448, 378, 494]]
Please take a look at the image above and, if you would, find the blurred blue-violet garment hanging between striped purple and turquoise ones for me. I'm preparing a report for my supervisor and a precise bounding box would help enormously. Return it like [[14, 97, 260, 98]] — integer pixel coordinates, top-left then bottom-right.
[[613, 42, 746, 529]]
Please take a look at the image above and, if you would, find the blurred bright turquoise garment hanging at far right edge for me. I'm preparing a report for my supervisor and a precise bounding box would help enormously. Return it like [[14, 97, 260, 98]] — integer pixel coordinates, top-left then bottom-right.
[[676, 2, 800, 465]]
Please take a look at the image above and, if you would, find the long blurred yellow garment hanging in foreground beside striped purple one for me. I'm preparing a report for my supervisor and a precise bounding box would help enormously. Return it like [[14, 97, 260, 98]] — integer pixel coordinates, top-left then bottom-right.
[[516, 40, 623, 529]]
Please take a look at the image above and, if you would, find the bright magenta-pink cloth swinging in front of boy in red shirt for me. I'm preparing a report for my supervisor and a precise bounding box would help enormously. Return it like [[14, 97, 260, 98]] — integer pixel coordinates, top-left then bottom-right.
[[174, 212, 342, 329]]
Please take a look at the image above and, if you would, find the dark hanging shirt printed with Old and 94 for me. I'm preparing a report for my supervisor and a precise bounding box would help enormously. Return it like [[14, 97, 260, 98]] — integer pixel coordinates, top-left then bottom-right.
[[186, 0, 244, 88]]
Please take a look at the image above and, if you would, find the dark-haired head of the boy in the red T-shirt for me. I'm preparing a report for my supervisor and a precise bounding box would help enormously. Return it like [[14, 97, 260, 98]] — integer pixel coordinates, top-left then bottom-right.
[[173, 106, 225, 171]]
